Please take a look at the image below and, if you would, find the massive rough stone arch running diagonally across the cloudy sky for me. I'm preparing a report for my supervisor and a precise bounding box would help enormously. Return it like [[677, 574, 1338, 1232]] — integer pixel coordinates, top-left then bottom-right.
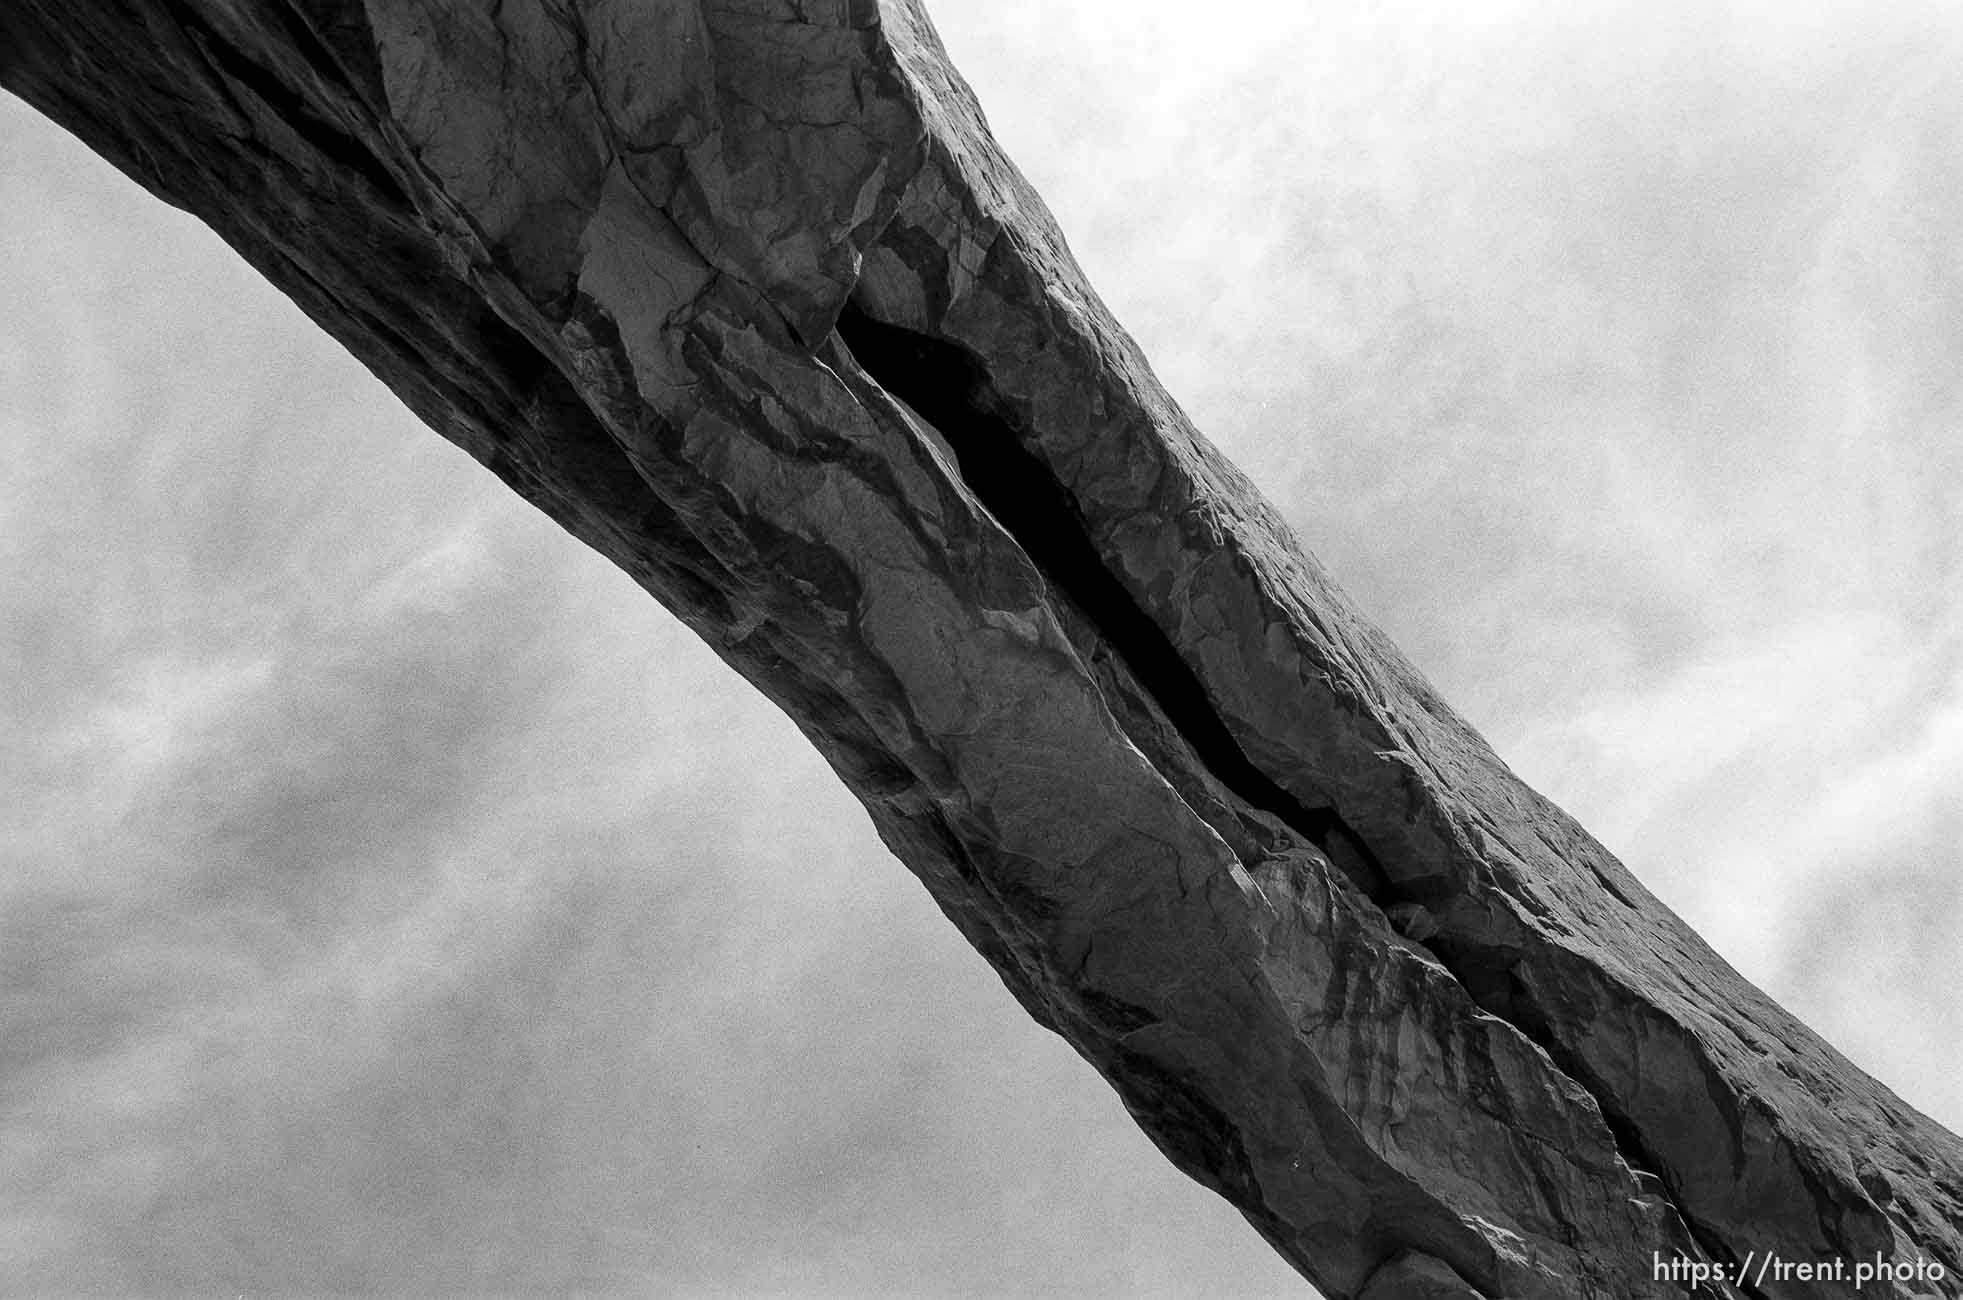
[[0, 0, 1963, 1300]]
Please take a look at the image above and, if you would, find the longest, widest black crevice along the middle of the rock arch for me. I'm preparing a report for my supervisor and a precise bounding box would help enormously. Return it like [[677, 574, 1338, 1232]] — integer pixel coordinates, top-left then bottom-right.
[[838, 302, 1396, 905]]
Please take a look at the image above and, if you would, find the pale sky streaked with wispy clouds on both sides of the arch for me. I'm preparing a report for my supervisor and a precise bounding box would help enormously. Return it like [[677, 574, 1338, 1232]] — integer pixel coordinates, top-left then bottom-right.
[[0, 0, 1963, 1298]]
